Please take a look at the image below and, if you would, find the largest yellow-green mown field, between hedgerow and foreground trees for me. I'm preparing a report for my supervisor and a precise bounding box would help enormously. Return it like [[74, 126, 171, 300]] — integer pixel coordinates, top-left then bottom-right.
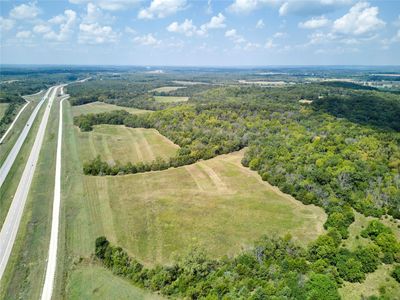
[[80, 148, 325, 264]]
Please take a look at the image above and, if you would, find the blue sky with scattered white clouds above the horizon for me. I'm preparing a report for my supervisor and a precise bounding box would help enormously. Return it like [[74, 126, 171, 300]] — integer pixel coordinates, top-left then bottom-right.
[[0, 0, 400, 66]]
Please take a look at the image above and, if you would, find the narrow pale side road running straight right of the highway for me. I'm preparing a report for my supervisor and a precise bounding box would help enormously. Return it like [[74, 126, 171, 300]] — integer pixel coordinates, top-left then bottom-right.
[[42, 98, 66, 300]]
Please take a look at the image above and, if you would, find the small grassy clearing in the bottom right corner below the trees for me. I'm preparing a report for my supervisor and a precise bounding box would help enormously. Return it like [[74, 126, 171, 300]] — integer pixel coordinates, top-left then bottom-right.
[[339, 265, 400, 300]]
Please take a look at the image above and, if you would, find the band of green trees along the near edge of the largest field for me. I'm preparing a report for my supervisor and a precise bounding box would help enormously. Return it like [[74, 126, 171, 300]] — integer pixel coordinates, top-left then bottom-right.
[[95, 221, 400, 300]]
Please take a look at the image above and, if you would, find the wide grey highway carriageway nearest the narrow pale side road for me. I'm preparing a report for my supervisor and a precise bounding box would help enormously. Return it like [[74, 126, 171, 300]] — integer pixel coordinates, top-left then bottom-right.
[[0, 86, 61, 280]]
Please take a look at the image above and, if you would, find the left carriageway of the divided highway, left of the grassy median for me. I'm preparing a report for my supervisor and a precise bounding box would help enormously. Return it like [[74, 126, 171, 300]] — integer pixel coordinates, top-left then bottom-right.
[[0, 88, 52, 188]]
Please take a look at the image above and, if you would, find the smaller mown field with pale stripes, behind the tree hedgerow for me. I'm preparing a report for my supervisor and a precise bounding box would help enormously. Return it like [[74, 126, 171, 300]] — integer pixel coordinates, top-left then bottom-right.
[[76, 125, 179, 164]]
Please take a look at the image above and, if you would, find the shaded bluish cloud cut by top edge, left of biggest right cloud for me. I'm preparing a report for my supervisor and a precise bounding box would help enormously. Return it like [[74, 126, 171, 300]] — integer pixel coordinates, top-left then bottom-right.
[[279, 0, 353, 16]]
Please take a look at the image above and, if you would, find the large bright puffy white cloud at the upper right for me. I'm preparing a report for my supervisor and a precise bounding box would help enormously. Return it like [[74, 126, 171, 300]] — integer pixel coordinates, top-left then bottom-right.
[[333, 2, 385, 35]]
